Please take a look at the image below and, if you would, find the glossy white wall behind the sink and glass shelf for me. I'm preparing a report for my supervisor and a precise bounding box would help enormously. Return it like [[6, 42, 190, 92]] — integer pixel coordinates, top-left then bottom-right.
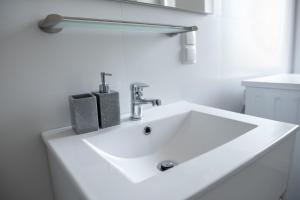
[[0, 0, 294, 200]]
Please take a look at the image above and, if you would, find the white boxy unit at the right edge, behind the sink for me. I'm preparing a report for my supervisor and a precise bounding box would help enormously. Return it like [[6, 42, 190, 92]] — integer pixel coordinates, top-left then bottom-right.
[[242, 74, 300, 200]]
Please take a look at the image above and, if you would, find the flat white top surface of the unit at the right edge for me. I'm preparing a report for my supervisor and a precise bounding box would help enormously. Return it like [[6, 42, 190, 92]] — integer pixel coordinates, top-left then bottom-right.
[[242, 74, 300, 90]]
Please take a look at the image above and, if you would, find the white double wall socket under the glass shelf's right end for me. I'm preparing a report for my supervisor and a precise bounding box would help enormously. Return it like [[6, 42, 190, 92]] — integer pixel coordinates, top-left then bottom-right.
[[181, 31, 197, 64]]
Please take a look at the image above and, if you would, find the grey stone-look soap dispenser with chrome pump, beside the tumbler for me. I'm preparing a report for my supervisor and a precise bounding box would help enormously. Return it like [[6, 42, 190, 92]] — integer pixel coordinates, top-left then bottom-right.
[[93, 72, 120, 128]]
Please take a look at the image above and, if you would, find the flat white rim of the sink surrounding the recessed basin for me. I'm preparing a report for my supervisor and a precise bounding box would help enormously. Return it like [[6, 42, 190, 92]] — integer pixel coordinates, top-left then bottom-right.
[[42, 101, 298, 200]]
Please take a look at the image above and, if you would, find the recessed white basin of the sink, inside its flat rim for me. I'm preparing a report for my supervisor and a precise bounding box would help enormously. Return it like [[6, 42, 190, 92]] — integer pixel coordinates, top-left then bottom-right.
[[84, 111, 256, 183]]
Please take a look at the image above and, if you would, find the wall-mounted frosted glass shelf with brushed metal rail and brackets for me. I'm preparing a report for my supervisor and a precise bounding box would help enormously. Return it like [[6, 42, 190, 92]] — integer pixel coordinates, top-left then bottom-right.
[[39, 14, 198, 36]]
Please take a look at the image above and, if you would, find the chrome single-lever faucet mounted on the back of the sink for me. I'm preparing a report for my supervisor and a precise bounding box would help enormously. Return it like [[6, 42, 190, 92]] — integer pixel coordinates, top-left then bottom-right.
[[130, 83, 161, 120]]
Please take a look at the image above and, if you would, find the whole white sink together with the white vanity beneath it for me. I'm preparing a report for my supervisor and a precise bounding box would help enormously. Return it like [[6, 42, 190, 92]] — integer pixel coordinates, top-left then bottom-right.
[[42, 102, 297, 200]]
